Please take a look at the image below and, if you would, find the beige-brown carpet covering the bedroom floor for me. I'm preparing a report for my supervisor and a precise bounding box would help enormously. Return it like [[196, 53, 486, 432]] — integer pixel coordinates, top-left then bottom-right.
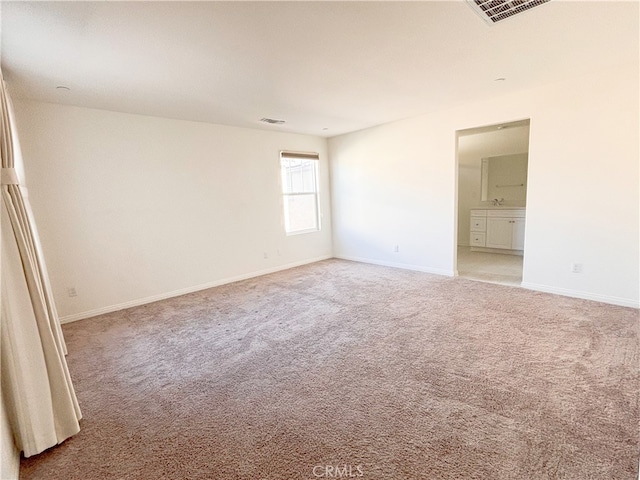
[[20, 260, 639, 480]]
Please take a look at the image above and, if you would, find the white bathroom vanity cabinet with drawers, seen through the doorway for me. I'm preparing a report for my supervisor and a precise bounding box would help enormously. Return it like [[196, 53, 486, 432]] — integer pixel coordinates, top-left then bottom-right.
[[469, 207, 525, 255]]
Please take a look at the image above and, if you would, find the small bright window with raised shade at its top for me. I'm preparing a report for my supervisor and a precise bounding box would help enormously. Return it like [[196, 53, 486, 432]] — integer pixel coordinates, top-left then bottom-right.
[[280, 152, 320, 235]]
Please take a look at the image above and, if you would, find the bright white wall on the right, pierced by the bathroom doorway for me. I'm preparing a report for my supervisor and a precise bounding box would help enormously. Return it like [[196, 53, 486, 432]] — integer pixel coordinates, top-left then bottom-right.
[[329, 63, 640, 306]]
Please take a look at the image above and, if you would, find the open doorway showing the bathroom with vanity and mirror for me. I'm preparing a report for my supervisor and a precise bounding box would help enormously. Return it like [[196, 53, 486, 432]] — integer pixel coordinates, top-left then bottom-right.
[[456, 119, 530, 286]]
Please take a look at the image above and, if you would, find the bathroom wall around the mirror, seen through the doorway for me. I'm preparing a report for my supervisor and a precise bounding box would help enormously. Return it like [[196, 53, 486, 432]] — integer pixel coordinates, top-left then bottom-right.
[[458, 125, 529, 246]]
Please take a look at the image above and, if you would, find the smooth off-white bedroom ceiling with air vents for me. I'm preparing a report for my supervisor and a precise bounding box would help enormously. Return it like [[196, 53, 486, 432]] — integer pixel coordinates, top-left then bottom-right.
[[1, 0, 639, 136]]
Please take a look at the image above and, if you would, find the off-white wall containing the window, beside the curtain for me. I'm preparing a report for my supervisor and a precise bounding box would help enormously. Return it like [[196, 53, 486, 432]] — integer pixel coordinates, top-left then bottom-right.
[[15, 101, 332, 321]]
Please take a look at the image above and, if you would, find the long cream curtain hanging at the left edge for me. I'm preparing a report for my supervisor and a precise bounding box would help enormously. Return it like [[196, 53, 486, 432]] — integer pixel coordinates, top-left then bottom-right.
[[0, 72, 81, 457]]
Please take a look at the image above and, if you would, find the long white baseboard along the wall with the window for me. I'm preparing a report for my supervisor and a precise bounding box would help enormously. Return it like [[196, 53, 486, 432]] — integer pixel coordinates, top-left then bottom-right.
[[60, 255, 333, 323]]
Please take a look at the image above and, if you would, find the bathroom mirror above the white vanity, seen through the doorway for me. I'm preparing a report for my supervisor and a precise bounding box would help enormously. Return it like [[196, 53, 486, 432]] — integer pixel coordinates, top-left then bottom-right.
[[480, 153, 529, 202]]
